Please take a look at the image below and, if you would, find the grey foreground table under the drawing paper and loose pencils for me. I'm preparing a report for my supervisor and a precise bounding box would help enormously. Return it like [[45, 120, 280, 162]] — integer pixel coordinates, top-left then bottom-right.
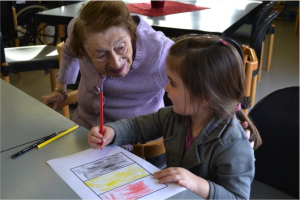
[[0, 79, 201, 199]]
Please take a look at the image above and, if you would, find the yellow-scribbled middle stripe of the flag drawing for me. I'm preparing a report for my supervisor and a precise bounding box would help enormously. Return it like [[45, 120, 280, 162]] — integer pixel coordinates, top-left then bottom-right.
[[85, 164, 149, 194]]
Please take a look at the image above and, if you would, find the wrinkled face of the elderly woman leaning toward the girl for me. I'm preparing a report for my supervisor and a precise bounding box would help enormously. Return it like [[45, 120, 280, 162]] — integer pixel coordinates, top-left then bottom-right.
[[84, 26, 132, 77]]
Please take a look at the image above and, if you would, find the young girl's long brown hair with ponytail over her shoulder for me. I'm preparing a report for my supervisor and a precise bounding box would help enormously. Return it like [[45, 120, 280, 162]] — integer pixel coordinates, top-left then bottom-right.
[[168, 35, 262, 149]]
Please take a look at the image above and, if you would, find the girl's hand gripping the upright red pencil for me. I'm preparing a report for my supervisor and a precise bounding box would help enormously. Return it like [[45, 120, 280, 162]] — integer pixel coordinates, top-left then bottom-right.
[[88, 126, 115, 149]]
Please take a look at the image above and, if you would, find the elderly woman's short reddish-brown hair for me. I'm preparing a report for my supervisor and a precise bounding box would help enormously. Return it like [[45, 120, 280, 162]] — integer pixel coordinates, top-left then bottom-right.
[[70, 1, 136, 58]]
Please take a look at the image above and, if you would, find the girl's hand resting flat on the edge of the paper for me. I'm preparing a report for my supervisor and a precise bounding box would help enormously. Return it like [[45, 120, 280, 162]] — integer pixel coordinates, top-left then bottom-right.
[[154, 167, 209, 199]]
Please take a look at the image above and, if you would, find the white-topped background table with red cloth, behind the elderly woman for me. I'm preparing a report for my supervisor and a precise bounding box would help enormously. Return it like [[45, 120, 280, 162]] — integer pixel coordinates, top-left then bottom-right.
[[36, 0, 262, 37]]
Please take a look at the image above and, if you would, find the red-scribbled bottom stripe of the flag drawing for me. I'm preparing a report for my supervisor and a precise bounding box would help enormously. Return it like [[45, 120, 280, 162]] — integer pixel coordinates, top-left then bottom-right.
[[101, 180, 153, 200]]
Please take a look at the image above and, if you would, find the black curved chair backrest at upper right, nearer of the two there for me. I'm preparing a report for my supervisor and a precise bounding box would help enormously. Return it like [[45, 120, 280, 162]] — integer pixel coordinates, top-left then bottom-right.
[[250, 10, 279, 76]]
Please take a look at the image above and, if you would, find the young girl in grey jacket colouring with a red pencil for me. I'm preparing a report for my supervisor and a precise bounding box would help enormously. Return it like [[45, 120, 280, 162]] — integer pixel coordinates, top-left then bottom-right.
[[89, 36, 261, 199]]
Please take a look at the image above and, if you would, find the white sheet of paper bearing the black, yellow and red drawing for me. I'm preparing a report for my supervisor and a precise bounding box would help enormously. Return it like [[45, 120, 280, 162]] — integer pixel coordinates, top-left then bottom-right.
[[47, 146, 186, 199]]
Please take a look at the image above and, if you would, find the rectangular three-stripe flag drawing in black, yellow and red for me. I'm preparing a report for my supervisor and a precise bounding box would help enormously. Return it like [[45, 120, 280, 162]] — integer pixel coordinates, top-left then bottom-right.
[[71, 152, 168, 200]]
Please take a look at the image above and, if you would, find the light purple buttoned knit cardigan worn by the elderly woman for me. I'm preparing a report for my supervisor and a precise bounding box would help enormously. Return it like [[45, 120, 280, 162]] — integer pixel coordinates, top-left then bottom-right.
[[56, 16, 174, 129]]
